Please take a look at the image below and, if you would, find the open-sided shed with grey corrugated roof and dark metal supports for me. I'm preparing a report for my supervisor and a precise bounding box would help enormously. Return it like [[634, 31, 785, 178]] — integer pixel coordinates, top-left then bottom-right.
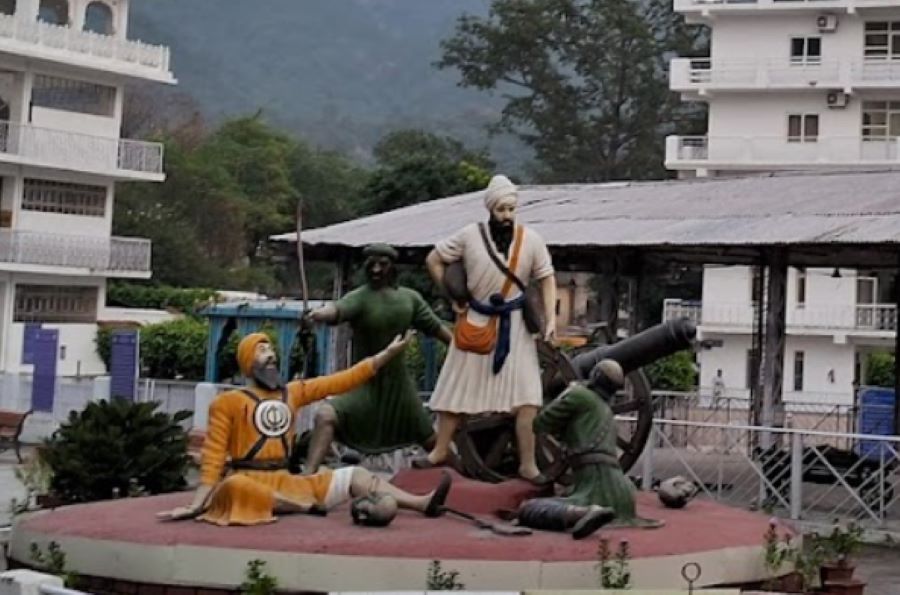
[[273, 172, 900, 433]]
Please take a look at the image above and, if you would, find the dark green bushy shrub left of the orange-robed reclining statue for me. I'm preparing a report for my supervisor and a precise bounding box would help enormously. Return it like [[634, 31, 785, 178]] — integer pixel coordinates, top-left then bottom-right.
[[43, 398, 191, 503]]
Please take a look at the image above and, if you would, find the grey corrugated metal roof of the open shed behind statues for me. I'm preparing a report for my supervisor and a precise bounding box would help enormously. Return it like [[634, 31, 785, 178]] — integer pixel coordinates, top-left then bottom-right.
[[273, 172, 900, 247]]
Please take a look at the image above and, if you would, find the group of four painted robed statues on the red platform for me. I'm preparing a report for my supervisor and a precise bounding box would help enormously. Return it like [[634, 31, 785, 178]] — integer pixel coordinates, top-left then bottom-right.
[[159, 176, 696, 539]]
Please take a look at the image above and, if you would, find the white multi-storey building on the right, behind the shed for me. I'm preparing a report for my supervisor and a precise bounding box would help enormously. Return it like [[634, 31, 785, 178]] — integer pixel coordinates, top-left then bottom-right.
[[665, 0, 900, 404]]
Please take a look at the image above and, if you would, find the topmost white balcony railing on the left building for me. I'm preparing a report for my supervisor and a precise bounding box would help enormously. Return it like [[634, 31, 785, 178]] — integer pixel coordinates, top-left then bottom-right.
[[0, 15, 171, 78]]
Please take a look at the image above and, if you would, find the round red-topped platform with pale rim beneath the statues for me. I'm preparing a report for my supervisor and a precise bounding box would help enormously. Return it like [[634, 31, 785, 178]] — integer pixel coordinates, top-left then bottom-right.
[[11, 472, 784, 591]]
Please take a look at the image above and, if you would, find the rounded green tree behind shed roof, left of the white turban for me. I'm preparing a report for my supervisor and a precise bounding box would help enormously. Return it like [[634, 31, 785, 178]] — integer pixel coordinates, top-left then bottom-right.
[[364, 130, 494, 212]]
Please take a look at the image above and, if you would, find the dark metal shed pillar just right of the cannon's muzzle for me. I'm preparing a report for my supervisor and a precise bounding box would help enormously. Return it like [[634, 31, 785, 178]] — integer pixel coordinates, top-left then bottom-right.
[[762, 250, 787, 440]]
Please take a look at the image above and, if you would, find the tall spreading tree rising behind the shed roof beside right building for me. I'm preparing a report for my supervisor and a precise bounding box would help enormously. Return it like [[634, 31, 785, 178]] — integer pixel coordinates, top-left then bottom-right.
[[437, 0, 703, 182]]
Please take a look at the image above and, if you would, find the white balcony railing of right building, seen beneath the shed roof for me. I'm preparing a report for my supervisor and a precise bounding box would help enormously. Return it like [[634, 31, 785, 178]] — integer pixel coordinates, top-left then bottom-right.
[[663, 299, 897, 331]]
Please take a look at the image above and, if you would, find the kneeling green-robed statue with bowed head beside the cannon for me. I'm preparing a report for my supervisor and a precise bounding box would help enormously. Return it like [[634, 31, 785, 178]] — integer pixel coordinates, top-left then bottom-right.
[[516, 360, 658, 539]]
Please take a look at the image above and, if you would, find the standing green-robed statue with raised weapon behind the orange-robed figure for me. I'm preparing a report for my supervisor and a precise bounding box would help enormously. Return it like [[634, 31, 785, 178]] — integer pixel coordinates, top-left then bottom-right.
[[306, 244, 452, 473]]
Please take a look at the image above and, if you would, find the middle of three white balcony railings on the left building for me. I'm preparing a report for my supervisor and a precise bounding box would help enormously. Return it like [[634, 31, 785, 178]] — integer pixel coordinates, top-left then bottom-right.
[[0, 121, 163, 175]]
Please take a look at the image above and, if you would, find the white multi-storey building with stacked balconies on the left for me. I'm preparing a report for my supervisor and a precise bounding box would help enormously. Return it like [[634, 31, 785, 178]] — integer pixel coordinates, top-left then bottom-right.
[[0, 0, 175, 375]]
